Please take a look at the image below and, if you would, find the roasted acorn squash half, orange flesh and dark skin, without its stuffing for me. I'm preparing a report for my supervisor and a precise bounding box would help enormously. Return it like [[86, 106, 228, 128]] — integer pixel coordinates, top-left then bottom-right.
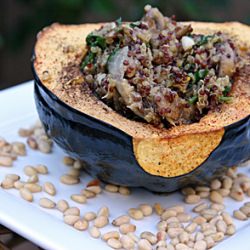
[[32, 22, 250, 192]]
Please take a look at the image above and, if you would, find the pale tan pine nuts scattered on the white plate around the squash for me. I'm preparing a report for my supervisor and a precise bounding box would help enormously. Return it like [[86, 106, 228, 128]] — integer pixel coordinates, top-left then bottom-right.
[[0, 123, 250, 250]]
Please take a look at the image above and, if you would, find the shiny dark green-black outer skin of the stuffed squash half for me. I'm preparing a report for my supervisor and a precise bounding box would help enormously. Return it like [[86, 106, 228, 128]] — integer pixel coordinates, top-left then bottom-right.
[[33, 66, 250, 192]]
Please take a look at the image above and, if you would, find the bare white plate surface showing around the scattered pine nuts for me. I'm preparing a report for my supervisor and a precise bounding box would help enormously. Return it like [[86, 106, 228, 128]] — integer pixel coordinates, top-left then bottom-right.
[[0, 82, 250, 250]]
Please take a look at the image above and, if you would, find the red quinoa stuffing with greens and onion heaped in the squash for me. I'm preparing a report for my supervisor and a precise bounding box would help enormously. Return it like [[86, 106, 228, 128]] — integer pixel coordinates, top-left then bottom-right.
[[82, 5, 238, 128]]
